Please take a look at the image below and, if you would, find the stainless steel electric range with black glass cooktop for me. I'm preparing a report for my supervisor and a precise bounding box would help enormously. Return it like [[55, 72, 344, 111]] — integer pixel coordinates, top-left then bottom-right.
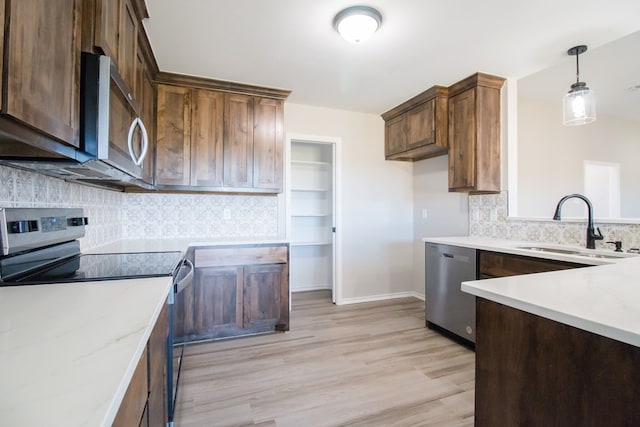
[[0, 208, 193, 421]]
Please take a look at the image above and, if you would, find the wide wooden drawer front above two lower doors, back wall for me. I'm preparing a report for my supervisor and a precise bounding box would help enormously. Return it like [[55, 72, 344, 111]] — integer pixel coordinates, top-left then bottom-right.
[[195, 245, 289, 268]]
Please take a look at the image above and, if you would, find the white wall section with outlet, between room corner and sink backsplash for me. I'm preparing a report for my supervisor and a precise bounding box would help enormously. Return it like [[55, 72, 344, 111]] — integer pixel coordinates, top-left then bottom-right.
[[413, 155, 469, 295]]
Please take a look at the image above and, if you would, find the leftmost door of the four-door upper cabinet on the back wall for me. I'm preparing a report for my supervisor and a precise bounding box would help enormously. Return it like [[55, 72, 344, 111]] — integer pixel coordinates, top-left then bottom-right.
[[156, 85, 191, 185]]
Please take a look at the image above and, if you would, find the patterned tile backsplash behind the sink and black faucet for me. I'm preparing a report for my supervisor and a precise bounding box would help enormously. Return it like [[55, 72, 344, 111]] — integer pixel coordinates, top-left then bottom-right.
[[469, 192, 640, 250]]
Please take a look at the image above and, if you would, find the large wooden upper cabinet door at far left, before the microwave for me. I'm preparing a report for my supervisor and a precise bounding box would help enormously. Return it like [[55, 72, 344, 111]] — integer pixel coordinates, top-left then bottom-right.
[[3, 0, 81, 146]]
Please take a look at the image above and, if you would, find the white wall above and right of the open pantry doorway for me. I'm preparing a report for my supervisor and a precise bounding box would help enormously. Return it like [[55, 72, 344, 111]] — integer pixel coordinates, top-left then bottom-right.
[[284, 103, 414, 303]]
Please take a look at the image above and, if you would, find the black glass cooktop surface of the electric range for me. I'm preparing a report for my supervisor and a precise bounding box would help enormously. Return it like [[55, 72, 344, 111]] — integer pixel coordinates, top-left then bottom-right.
[[11, 252, 182, 285]]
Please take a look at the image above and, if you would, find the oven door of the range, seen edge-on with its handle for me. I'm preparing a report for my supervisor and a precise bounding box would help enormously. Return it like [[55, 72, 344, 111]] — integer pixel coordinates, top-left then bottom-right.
[[167, 259, 194, 425]]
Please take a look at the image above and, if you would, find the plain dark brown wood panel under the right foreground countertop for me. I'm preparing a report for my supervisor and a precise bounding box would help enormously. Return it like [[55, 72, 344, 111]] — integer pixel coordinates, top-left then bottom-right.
[[475, 298, 640, 427]]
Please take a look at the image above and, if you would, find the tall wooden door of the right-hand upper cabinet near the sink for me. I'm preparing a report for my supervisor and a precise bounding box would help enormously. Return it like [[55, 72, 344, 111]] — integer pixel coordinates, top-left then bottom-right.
[[449, 88, 476, 191]]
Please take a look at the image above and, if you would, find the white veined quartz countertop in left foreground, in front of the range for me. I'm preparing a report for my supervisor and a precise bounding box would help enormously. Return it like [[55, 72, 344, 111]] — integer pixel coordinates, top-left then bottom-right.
[[0, 277, 172, 427]]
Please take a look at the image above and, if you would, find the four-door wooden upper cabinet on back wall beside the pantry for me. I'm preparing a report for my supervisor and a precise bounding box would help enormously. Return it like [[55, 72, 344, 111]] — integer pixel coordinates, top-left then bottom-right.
[[155, 73, 289, 193]]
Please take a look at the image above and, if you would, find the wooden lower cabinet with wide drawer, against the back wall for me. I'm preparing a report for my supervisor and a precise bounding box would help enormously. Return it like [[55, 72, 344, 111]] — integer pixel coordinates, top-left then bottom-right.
[[176, 244, 289, 342]]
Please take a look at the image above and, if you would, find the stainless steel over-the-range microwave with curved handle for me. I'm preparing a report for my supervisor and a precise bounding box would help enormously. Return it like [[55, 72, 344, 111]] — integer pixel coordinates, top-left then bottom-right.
[[1, 52, 152, 188]]
